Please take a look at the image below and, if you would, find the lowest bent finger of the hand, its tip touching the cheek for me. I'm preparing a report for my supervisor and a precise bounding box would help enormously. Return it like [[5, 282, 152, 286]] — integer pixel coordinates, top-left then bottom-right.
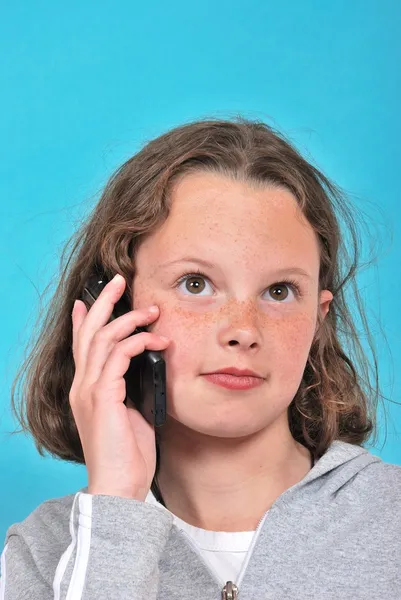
[[96, 332, 170, 402]]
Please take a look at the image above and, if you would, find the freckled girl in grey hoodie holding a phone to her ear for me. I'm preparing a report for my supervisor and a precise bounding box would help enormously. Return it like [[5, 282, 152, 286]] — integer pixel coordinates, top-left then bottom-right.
[[1, 119, 401, 600]]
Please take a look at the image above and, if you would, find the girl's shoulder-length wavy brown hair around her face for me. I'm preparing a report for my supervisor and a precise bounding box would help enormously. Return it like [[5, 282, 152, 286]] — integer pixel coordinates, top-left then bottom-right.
[[7, 116, 392, 497]]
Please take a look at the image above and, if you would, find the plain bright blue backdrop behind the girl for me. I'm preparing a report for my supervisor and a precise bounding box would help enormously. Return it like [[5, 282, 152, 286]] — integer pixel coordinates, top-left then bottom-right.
[[0, 0, 401, 540]]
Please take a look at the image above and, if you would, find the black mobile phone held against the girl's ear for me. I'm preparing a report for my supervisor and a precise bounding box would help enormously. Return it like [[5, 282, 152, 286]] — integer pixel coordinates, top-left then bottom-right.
[[81, 271, 167, 427]]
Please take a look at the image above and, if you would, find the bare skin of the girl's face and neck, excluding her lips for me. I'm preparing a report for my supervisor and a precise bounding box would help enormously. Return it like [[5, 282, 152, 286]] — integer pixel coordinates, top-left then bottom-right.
[[133, 172, 333, 531]]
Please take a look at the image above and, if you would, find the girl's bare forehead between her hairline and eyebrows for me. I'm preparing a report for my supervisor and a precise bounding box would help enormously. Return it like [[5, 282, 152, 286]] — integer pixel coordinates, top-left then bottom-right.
[[141, 173, 318, 264]]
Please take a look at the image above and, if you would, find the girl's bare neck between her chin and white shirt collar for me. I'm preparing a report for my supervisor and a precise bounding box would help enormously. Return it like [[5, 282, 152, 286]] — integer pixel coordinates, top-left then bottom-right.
[[157, 418, 312, 532]]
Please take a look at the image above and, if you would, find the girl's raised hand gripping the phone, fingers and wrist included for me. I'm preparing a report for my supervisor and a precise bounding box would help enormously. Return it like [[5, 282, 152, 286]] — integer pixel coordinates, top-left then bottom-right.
[[69, 276, 170, 501]]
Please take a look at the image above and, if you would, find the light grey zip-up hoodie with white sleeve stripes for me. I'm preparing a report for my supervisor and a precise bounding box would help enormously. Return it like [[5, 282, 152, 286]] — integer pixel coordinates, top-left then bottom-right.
[[0, 441, 401, 600]]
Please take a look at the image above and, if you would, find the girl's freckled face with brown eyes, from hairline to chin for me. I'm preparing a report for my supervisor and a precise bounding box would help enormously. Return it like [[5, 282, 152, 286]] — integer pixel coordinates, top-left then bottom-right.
[[133, 173, 333, 438]]
